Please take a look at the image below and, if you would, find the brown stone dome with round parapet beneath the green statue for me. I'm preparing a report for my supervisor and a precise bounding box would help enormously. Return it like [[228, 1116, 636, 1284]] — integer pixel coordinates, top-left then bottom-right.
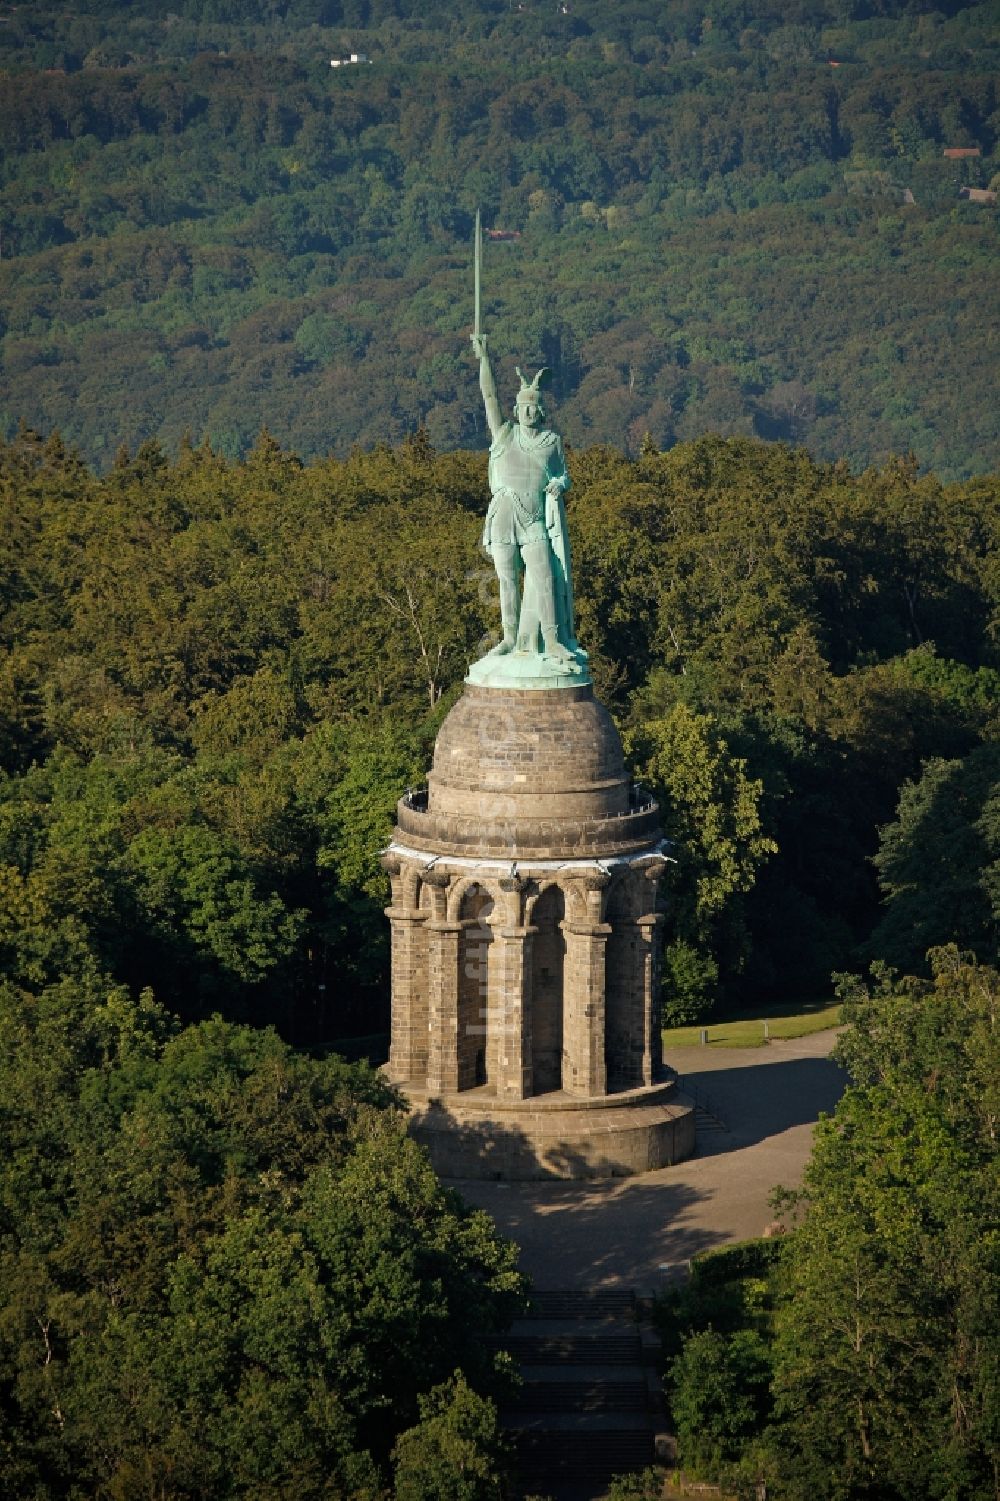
[[398, 684, 659, 859]]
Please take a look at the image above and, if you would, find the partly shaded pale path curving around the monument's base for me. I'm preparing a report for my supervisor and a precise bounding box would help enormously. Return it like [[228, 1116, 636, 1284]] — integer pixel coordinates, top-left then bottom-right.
[[453, 1031, 847, 1289]]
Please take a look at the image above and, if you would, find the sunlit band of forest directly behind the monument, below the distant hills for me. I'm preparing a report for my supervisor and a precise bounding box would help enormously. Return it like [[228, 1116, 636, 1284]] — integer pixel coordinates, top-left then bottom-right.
[[0, 432, 1000, 1043]]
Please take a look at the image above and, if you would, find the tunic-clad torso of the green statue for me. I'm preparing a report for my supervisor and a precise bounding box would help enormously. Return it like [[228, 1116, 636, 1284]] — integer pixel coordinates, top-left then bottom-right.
[[482, 422, 569, 548]]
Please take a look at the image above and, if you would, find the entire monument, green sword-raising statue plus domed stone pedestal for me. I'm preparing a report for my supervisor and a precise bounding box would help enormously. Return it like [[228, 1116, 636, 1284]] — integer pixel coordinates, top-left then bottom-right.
[[383, 218, 694, 1178]]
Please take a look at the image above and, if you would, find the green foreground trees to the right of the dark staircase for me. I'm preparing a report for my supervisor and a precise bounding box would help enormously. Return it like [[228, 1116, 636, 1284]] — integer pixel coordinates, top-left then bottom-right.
[[649, 946, 1000, 1501]]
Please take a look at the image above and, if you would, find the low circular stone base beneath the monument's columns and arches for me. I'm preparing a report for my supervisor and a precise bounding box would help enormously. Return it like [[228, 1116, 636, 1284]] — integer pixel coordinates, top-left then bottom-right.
[[399, 1082, 695, 1180]]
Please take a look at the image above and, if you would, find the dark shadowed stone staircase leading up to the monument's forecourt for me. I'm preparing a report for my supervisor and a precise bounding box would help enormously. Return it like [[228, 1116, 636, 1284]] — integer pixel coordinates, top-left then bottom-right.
[[503, 1291, 662, 1501]]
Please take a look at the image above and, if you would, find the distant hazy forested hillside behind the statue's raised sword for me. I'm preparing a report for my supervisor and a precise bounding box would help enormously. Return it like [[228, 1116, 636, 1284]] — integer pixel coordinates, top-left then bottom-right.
[[0, 0, 1000, 479]]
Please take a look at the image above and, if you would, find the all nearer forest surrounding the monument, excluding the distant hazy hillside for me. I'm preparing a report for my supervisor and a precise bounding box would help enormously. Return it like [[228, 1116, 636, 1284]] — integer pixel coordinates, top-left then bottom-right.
[[0, 429, 1000, 1501]]
